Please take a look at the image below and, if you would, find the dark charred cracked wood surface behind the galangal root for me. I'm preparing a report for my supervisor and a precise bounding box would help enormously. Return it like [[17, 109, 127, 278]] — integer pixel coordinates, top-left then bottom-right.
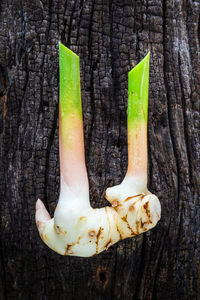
[[0, 0, 200, 300]]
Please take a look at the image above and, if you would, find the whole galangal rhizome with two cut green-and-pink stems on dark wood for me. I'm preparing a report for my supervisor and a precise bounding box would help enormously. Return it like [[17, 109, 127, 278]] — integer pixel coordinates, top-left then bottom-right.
[[36, 43, 161, 257]]
